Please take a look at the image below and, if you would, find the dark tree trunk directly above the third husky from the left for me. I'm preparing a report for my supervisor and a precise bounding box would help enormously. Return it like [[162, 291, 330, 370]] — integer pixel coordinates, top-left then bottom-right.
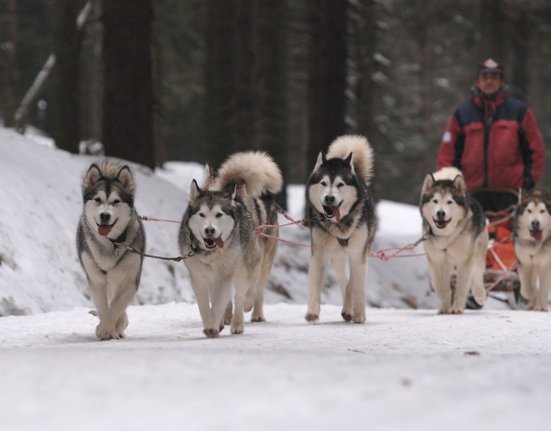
[[307, 0, 348, 167]]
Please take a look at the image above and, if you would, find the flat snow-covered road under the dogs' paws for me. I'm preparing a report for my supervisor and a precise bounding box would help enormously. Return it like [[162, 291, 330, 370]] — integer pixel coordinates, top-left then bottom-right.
[[0, 303, 551, 431]]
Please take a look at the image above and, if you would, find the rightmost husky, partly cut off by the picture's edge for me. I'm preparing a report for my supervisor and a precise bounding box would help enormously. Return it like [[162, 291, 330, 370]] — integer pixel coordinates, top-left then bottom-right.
[[513, 191, 551, 311]]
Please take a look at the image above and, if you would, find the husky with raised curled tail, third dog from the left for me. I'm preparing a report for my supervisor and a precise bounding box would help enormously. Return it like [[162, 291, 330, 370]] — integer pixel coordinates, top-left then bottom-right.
[[306, 136, 377, 323]]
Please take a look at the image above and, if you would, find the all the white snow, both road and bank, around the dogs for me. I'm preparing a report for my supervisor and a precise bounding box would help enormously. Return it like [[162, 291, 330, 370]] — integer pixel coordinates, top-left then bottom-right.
[[0, 129, 551, 431]]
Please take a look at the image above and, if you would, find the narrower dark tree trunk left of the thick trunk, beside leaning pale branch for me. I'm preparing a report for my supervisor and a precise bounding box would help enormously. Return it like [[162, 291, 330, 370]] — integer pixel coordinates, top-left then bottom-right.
[[53, 0, 80, 153]]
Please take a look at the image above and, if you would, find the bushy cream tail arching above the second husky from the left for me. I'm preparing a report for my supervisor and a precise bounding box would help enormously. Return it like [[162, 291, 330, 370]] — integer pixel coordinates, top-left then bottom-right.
[[215, 151, 283, 197]]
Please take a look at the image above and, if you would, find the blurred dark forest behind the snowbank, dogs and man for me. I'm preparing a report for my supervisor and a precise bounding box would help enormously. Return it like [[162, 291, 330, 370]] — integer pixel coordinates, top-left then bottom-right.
[[0, 0, 551, 203]]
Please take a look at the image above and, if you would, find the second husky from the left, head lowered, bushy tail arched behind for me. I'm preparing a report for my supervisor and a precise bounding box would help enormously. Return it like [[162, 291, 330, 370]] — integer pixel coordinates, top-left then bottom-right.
[[178, 152, 283, 338]]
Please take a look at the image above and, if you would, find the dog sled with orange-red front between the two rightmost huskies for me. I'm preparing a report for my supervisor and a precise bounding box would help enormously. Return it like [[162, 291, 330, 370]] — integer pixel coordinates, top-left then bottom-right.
[[467, 189, 523, 309]]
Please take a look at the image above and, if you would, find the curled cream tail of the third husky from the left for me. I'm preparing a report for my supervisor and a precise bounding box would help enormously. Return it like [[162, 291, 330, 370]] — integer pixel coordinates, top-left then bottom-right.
[[327, 135, 374, 184]]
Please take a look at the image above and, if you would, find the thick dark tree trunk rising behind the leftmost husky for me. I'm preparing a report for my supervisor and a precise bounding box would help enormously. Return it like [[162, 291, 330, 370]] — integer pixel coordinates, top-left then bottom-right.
[[102, 0, 156, 168]]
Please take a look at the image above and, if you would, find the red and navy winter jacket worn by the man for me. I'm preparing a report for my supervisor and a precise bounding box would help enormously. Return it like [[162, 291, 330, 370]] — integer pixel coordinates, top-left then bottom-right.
[[437, 91, 544, 192]]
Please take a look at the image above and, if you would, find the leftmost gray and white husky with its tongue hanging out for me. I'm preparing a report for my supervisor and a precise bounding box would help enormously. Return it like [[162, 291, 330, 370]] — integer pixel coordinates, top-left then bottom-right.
[[77, 161, 145, 340]]
